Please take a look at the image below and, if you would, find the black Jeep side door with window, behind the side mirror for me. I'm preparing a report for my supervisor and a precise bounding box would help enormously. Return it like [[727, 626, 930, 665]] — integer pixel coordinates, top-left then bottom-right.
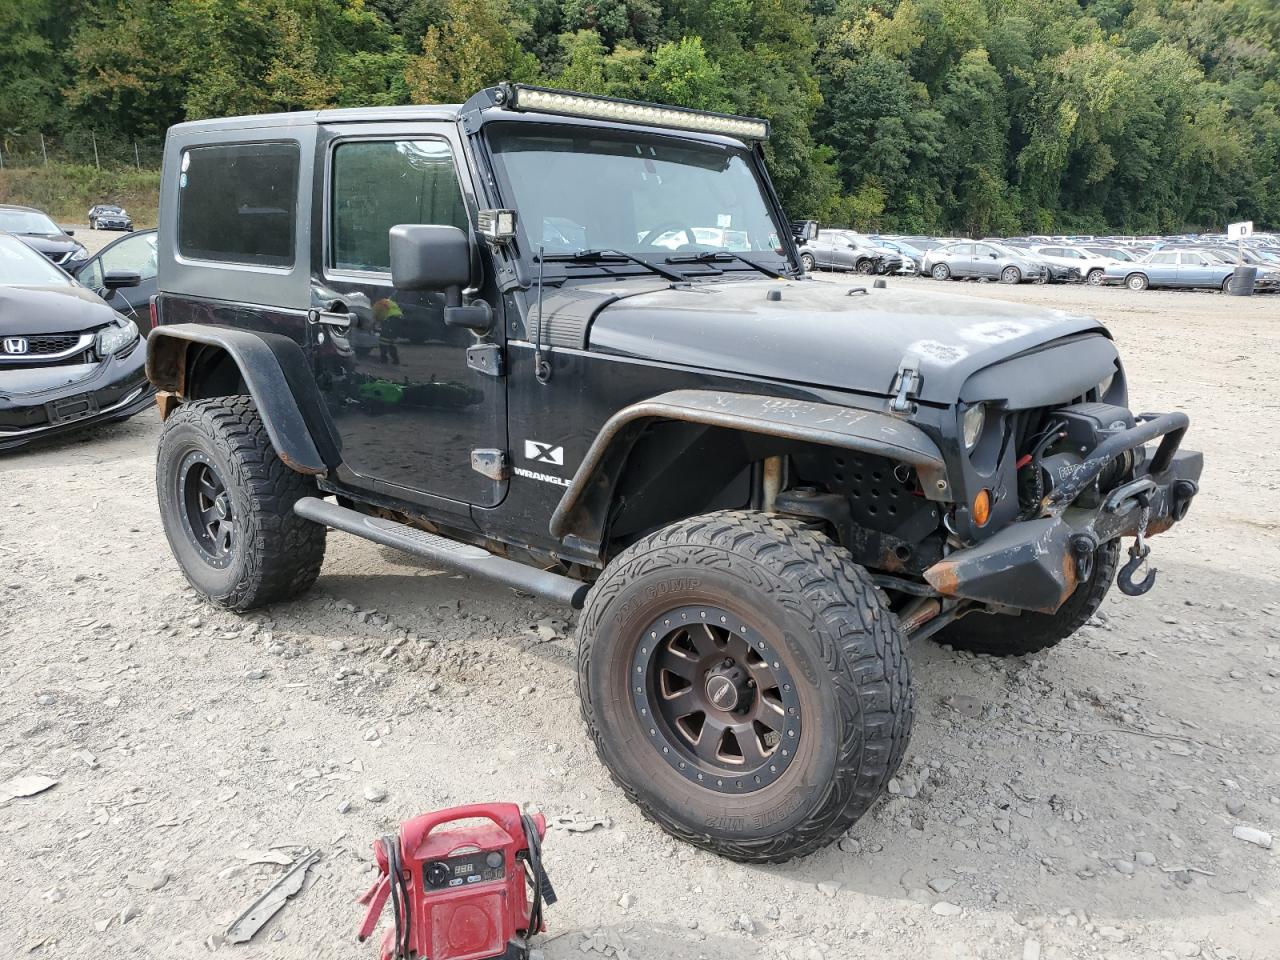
[[308, 123, 507, 507]]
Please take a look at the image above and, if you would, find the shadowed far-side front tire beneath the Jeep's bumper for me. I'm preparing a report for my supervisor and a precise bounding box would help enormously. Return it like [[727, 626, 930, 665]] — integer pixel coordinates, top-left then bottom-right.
[[934, 540, 1120, 657]]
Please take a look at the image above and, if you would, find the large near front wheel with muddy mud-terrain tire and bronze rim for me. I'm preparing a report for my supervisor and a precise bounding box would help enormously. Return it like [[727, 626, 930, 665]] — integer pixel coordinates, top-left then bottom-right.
[[579, 512, 913, 863]]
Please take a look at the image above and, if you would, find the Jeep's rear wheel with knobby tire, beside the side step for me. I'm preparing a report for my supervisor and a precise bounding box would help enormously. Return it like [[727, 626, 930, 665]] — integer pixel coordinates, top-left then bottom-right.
[[156, 397, 325, 611]]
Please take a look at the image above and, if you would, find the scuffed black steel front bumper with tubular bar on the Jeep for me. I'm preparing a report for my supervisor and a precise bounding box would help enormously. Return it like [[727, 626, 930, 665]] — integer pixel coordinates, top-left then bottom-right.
[[924, 413, 1204, 613]]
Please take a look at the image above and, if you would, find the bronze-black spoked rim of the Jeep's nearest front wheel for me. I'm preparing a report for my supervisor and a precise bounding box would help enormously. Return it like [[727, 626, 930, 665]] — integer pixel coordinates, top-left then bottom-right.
[[631, 604, 803, 794]]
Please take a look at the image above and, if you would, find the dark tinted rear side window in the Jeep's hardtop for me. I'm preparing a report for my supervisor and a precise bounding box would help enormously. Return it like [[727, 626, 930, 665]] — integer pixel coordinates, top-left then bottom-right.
[[178, 143, 298, 266]]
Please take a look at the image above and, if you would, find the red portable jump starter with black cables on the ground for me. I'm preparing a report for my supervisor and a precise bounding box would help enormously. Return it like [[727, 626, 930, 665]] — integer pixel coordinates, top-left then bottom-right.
[[358, 804, 556, 960]]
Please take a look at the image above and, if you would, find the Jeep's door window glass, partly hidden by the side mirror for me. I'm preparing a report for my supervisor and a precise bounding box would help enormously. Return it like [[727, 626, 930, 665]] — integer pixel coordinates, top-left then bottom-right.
[[330, 140, 468, 273]]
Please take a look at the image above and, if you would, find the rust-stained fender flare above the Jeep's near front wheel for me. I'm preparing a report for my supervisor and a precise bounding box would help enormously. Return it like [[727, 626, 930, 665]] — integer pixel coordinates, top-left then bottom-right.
[[550, 390, 951, 539]]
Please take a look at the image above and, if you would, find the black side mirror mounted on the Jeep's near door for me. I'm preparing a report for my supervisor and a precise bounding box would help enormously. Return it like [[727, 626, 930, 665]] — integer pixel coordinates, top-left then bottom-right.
[[390, 224, 493, 330]]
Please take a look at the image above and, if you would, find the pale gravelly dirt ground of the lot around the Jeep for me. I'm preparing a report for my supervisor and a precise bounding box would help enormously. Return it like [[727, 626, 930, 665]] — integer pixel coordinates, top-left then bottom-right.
[[0, 273, 1280, 960]]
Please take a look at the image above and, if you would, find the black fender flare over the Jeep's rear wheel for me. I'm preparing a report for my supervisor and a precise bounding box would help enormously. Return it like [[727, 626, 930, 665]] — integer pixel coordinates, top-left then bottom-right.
[[147, 324, 342, 475]]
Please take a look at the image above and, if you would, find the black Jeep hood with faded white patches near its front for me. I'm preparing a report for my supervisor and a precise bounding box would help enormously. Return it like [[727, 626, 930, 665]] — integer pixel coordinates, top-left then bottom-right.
[[577, 279, 1106, 404]]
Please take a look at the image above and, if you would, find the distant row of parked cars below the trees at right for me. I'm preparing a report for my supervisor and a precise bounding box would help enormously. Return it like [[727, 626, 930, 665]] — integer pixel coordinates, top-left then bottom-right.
[[800, 228, 1280, 292]]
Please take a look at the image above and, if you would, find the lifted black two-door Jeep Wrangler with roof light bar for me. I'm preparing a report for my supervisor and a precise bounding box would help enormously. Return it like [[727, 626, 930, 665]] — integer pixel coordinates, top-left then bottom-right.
[[147, 84, 1202, 861]]
